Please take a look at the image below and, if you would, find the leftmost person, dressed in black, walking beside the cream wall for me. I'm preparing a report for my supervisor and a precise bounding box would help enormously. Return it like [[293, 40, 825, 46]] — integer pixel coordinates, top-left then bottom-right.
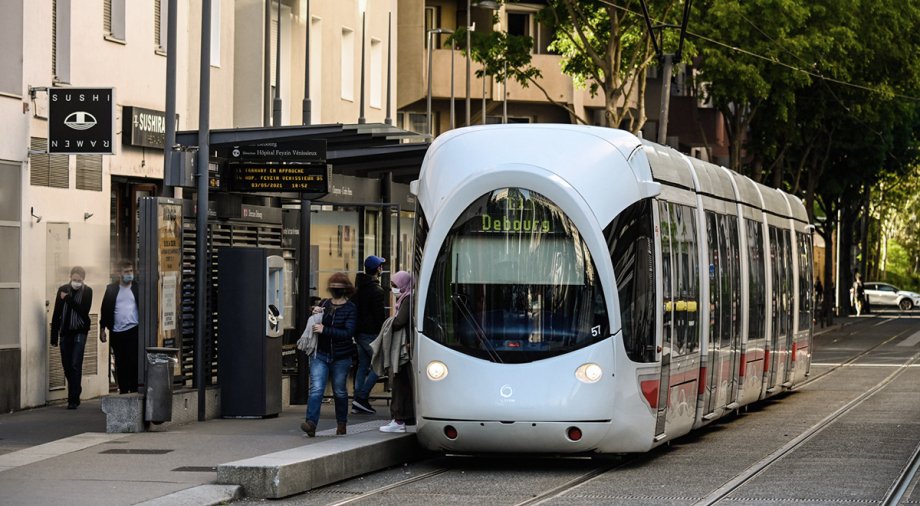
[[51, 266, 93, 409]]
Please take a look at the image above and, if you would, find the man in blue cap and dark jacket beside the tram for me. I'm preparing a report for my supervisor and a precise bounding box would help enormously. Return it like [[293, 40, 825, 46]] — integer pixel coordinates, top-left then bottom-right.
[[351, 255, 387, 413]]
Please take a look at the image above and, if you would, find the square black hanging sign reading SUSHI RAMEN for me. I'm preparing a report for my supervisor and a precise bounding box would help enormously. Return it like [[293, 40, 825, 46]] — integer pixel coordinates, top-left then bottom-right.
[[48, 88, 115, 155]]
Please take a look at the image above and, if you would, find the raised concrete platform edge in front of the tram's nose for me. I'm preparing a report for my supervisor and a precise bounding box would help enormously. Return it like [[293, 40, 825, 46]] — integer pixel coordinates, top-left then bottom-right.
[[217, 420, 430, 499]]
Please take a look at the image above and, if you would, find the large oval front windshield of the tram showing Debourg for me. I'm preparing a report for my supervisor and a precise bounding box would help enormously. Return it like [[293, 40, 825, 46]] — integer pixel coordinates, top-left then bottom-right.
[[422, 188, 609, 363]]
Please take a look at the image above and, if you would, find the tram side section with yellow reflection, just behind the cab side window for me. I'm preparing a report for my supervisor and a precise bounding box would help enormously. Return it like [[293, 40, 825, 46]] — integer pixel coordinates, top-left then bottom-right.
[[655, 202, 700, 437]]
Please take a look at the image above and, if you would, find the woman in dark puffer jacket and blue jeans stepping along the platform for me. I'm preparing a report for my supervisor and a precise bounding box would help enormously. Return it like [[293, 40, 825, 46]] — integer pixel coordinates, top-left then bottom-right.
[[300, 272, 358, 437]]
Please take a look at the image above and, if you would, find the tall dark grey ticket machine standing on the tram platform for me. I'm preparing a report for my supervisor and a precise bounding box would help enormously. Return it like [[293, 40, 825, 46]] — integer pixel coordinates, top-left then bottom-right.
[[217, 247, 289, 418]]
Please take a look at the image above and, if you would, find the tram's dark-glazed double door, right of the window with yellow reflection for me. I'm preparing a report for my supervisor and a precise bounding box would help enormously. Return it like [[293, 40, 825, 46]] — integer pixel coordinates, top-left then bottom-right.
[[703, 211, 741, 420]]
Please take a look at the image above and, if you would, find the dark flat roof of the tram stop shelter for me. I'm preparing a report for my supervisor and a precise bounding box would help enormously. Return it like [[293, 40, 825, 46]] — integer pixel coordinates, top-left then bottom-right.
[[176, 123, 430, 183]]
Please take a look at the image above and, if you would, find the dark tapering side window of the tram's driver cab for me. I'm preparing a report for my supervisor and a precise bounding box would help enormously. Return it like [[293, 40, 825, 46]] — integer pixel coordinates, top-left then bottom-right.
[[604, 199, 656, 362]]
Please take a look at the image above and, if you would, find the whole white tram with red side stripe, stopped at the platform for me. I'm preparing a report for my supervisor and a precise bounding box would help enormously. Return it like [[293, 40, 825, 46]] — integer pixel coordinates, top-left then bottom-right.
[[413, 125, 813, 453]]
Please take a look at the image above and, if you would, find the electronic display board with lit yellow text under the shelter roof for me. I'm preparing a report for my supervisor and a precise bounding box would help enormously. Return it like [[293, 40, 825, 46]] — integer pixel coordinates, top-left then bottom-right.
[[227, 163, 331, 193]]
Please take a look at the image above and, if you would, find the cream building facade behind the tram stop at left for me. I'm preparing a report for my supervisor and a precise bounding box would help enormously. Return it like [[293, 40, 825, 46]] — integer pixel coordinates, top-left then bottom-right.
[[0, 0, 398, 411]]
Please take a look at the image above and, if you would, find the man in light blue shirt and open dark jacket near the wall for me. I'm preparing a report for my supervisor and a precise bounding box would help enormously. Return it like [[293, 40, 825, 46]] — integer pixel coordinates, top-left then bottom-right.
[[99, 260, 140, 394]]
